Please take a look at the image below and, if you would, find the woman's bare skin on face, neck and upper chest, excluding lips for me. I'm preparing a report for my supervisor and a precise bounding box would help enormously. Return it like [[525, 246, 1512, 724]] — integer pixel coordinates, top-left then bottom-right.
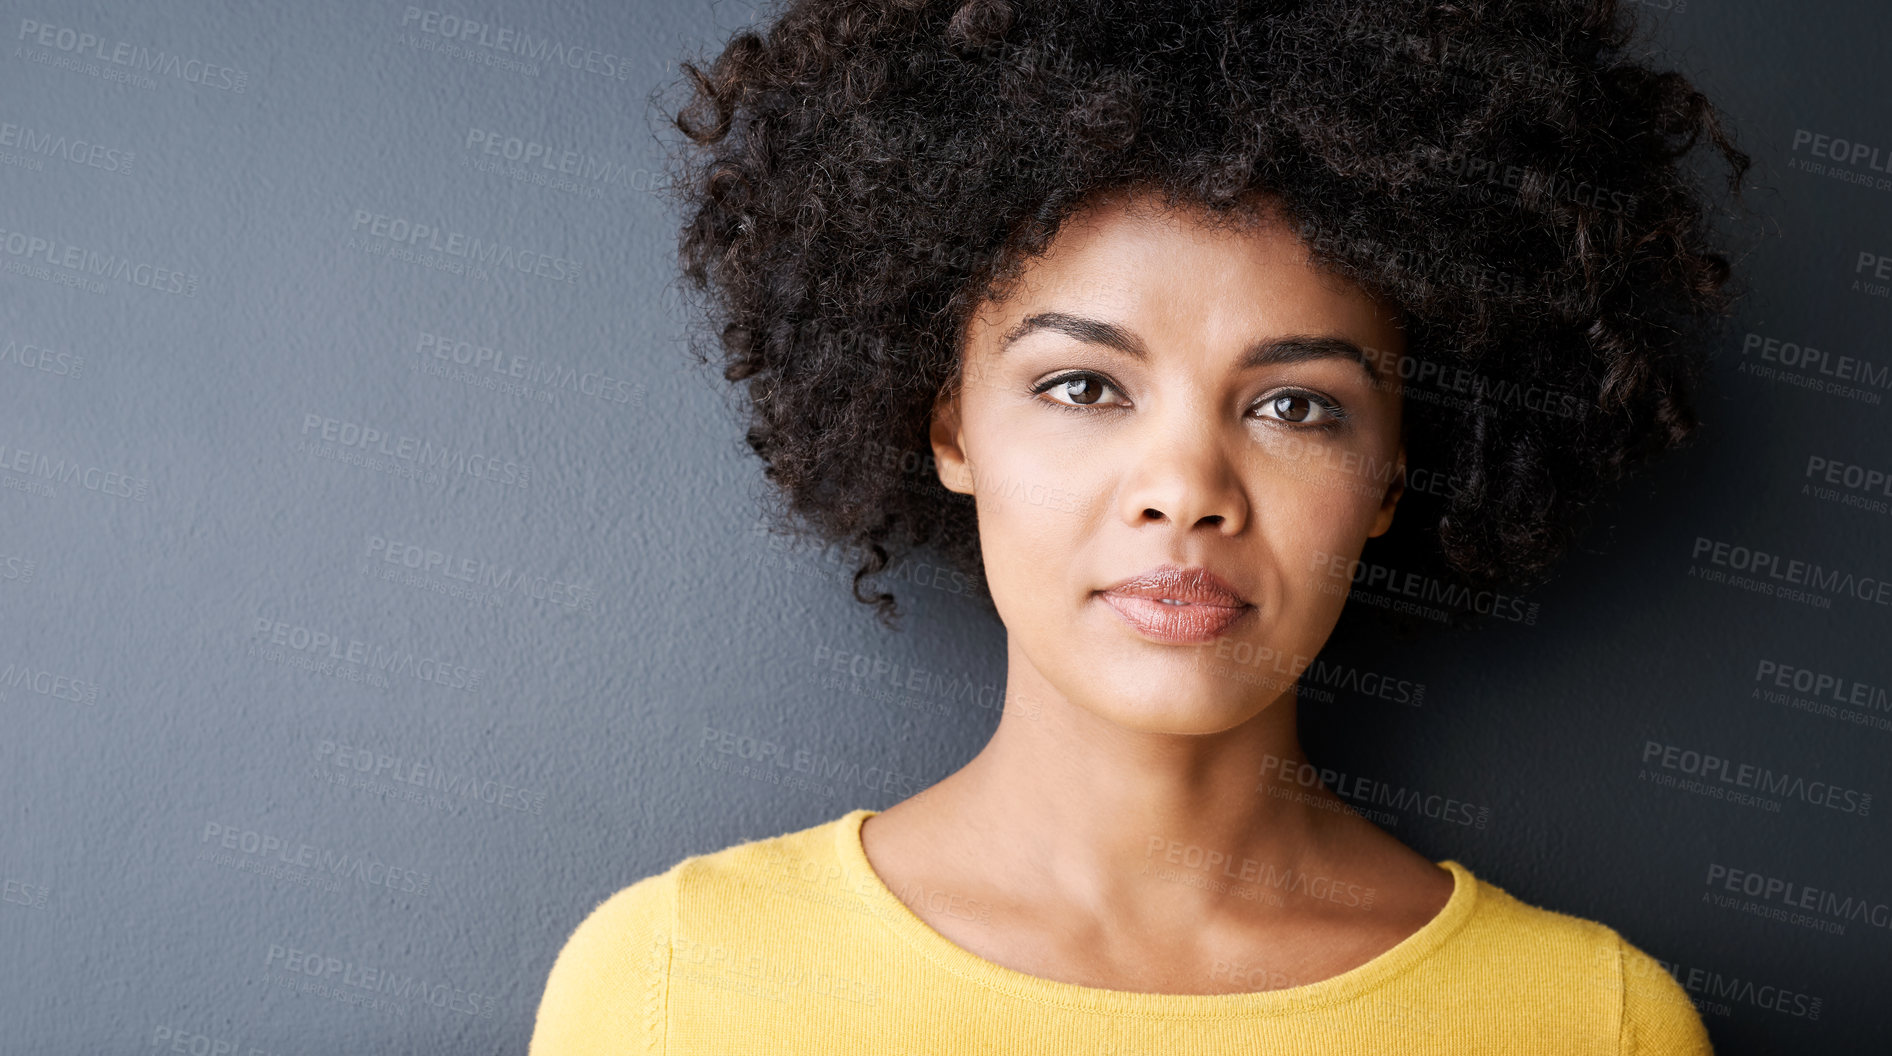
[[861, 189, 1453, 994]]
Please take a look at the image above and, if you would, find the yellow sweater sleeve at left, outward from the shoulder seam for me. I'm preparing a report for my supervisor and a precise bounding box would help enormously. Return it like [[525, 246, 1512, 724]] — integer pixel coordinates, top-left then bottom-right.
[[526, 869, 677, 1056]]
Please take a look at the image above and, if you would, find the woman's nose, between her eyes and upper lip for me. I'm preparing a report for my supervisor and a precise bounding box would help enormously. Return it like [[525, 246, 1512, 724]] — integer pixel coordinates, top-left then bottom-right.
[[1118, 407, 1249, 536]]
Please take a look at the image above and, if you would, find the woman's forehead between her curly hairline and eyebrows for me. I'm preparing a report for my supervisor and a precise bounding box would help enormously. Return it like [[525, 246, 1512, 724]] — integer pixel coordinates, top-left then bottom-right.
[[982, 193, 1404, 365]]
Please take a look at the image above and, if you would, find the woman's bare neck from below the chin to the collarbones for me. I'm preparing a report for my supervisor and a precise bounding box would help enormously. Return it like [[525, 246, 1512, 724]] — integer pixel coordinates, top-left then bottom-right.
[[925, 635, 1349, 916]]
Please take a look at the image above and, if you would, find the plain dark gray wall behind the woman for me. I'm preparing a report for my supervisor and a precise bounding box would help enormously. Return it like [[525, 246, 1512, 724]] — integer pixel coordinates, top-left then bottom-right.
[[0, 0, 1892, 1056]]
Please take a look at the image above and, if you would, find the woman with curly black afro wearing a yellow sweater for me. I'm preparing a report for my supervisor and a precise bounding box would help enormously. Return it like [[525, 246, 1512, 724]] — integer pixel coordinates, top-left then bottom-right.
[[532, 0, 1746, 1056]]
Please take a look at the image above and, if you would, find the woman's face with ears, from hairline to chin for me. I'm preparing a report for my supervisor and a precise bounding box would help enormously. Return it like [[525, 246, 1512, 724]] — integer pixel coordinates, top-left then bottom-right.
[[933, 195, 1404, 734]]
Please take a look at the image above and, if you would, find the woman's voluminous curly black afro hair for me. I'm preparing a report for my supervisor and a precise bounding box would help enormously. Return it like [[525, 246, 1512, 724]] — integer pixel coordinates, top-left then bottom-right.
[[666, 0, 1748, 625]]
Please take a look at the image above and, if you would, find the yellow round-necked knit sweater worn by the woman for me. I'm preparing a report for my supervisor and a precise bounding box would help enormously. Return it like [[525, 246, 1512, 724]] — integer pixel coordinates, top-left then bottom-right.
[[530, 808, 1712, 1056]]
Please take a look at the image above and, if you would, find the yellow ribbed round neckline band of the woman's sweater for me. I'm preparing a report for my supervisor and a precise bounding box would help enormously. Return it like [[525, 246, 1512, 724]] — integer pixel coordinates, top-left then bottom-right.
[[834, 806, 1478, 1016]]
